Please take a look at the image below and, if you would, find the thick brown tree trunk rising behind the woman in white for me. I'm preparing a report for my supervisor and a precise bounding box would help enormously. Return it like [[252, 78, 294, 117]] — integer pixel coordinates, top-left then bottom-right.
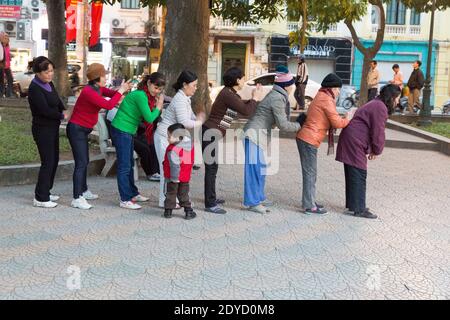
[[159, 0, 211, 112]]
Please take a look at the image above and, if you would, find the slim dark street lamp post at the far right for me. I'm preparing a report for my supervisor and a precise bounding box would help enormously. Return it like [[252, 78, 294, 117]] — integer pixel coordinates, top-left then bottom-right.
[[417, 0, 436, 126]]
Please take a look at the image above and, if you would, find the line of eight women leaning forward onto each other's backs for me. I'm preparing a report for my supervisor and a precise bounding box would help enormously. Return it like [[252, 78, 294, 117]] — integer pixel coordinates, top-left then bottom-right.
[[28, 57, 400, 218]]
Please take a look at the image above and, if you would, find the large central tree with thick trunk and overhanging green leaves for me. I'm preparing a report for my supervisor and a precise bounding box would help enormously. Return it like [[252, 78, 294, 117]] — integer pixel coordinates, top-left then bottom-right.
[[103, 0, 284, 111]]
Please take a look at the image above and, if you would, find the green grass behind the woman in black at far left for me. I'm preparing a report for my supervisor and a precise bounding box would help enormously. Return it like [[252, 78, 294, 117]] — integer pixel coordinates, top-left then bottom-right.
[[0, 108, 71, 165]]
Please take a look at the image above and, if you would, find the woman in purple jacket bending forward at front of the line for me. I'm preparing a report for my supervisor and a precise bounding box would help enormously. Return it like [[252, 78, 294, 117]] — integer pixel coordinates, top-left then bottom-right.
[[336, 84, 401, 219]]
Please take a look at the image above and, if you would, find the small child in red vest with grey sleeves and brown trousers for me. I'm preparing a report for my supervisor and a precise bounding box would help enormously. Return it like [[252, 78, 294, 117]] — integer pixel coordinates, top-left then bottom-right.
[[163, 123, 197, 220]]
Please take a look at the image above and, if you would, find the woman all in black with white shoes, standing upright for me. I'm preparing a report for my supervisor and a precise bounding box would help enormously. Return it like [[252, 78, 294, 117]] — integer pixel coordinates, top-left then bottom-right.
[[28, 56, 64, 208]]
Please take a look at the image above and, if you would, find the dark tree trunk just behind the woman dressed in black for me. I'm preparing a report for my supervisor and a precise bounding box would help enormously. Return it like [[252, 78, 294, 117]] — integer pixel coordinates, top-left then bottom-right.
[[47, 1, 71, 97]]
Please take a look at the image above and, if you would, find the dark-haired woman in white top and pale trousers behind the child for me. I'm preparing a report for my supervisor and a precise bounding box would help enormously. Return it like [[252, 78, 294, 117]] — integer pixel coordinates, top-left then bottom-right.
[[154, 70, 206, 208]]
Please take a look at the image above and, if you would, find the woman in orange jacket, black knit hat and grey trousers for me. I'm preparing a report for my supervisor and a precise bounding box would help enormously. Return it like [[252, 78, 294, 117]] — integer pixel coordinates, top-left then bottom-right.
[[297, 73, 349, 214]]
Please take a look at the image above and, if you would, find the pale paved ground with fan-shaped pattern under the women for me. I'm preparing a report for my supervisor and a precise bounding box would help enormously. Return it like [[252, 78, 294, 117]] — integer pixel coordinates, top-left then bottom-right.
[[0, 139, 450, 299]]
